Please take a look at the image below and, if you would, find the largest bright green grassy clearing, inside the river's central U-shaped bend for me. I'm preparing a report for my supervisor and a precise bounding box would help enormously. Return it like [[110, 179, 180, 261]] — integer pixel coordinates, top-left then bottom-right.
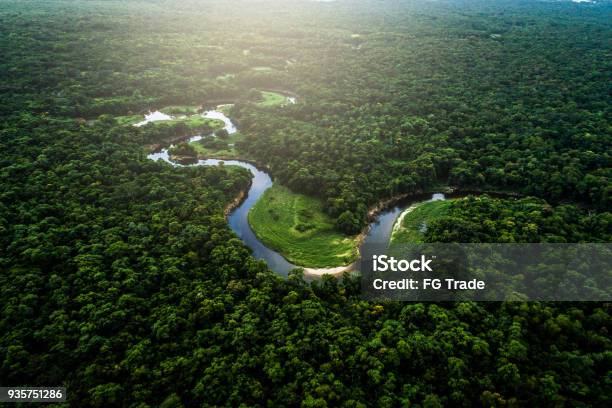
[[249, 184, 358, 268]]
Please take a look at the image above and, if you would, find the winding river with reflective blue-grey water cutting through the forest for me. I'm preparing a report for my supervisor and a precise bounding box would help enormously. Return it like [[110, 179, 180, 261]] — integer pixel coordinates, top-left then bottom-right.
[[146, 110, 445, 276]]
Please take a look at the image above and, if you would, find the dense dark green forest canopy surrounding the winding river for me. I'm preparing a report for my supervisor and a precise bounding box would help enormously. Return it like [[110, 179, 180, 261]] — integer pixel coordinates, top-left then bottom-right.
[[0, 0, 612, 407]]
